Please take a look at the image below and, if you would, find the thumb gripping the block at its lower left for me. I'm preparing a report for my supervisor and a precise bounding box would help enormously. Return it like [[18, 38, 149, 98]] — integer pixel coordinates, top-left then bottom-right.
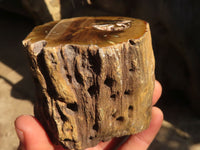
[[15, 115, 54, 150]]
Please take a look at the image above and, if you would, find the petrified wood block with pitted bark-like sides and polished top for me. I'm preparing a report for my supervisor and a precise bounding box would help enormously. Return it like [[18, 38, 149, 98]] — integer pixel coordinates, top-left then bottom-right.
[[23, 17, 154, 150]]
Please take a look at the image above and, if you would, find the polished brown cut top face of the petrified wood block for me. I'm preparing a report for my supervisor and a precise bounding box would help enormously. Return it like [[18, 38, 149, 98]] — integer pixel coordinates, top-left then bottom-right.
[[24, 17, 147, 47]]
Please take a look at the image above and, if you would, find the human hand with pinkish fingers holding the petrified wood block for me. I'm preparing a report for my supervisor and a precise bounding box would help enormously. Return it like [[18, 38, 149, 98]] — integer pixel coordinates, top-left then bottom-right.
[[15, 81, 163, 150]]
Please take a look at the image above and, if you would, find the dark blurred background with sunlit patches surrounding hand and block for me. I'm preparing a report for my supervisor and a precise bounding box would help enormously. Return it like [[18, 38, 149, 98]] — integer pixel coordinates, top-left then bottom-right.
[[0, 0, 200, 150]]
